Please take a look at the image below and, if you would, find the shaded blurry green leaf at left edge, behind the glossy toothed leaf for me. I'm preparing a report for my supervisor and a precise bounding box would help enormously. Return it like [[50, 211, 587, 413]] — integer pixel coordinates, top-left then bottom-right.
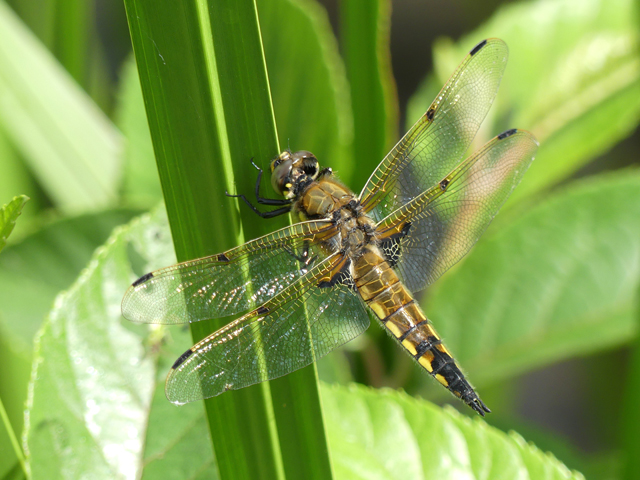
[[0, 210, 140, 476]]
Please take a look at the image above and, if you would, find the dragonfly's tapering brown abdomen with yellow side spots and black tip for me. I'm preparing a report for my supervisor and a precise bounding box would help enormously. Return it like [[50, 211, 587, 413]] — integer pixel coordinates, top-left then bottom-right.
[[354, 248, 489, 415]]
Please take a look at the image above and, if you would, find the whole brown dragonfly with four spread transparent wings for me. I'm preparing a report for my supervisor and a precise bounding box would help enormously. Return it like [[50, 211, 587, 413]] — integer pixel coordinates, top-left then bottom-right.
[[122, 38, 538, 416]]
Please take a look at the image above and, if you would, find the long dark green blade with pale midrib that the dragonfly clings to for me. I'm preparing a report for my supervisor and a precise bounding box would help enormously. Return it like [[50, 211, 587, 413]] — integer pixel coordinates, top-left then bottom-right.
[[127, 1, 336, 478]]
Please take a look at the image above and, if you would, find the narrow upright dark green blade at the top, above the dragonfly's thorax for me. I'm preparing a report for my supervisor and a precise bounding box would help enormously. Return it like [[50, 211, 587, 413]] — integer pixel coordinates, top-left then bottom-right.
[[340, 0, 398, 191]]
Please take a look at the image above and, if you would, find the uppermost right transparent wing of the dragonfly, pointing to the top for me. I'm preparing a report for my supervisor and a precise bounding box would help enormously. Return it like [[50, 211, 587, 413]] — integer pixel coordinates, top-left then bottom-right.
[[360, 38, 508, 221]]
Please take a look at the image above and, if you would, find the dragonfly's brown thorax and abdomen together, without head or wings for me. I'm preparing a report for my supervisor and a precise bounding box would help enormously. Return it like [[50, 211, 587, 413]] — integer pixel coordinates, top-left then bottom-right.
[[293, 175, 489, 411]]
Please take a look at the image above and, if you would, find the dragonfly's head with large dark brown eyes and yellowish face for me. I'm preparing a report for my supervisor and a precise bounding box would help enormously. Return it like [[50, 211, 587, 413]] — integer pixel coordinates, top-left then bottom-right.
[[271, 150, 319, 198]]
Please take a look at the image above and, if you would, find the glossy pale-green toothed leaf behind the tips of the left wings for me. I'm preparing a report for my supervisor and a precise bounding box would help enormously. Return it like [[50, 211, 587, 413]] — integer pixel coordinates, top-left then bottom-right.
[[25, 207, 217, 480]]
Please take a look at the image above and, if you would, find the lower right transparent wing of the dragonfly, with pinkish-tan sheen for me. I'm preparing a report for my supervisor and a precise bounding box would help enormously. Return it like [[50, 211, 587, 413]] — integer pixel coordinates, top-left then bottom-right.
[[378, 130, 538, 292]]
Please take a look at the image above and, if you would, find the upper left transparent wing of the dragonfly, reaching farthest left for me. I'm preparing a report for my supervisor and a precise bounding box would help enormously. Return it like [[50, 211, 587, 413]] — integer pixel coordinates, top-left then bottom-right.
[[122, 221, 335, 324]]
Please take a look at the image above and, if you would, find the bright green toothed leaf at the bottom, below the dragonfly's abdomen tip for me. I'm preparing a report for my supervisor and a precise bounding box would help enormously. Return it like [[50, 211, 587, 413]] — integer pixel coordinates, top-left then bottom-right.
[[322, 386, 584, 480]]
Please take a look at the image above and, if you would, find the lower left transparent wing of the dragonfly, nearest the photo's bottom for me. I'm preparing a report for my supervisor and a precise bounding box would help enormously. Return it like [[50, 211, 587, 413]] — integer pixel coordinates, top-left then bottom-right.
[[165, 254, 369, 404]]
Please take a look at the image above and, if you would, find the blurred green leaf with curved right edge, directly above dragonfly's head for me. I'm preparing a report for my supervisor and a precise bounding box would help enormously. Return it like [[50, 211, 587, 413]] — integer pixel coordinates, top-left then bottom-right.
[[257, 0, 355, 182]]
